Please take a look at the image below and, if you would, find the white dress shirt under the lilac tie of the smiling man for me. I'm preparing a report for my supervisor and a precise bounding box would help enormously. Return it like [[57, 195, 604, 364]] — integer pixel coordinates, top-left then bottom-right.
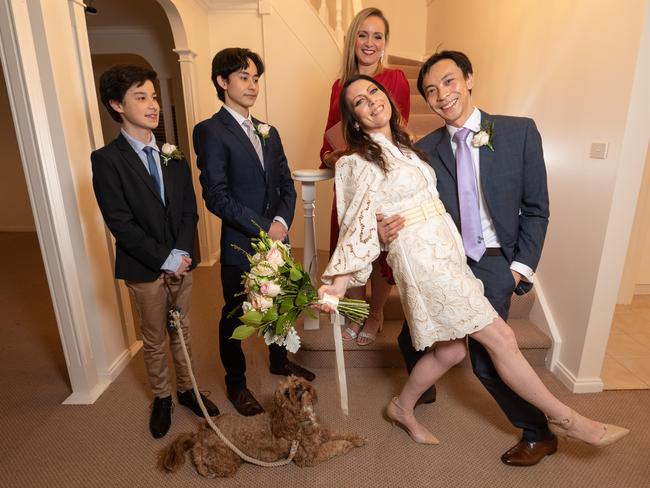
[[447, 107, 535, 283]]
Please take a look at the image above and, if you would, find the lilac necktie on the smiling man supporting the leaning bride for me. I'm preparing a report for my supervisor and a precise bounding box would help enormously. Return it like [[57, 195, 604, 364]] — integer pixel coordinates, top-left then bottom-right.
[[454, 127, 485, 261]]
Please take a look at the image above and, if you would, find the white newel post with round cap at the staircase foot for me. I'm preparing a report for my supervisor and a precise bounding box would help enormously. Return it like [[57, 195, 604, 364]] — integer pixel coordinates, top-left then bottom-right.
[[292, 169, 334, 330]]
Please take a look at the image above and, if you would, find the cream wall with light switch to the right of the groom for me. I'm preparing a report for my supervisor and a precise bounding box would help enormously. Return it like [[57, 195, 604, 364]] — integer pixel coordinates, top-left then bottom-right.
[[427, 0, 647, 388]]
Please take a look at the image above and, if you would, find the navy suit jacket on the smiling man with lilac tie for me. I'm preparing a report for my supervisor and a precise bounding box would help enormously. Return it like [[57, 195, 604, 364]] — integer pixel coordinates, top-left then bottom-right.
[[417, 111, 549, 292]]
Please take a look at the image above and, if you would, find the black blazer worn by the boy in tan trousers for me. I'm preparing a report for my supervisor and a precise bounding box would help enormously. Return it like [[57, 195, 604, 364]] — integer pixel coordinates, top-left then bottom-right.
[[90, 134, 199, 281]]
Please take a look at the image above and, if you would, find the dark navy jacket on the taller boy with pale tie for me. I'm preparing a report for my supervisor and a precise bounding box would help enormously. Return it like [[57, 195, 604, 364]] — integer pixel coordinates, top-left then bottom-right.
[[193, 108, 296, 265]]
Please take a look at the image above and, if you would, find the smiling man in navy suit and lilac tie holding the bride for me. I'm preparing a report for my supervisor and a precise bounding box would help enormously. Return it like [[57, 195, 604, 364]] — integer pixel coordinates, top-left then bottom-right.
[[379, 51, 557, 466]]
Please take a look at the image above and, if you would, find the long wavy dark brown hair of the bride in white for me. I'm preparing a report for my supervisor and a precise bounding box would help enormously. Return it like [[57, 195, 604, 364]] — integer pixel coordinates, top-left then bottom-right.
[[339, 75, 427, 173]]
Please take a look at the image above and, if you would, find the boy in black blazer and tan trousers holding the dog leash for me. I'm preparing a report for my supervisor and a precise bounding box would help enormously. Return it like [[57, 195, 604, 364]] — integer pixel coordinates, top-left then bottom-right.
[[90, 65, 219, 438]]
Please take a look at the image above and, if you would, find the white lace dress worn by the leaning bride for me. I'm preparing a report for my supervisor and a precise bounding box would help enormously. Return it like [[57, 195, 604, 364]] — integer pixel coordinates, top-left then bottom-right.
[[322, 135, 497, 350]]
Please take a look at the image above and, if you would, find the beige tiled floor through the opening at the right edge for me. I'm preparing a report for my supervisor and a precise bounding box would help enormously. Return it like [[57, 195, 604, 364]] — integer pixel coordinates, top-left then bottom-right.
[[601, 295, 650, 390]]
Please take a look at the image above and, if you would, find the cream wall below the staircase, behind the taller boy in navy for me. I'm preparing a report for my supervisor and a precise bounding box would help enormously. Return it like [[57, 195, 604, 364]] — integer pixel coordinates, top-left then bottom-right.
[[201, 0, 340, 249]]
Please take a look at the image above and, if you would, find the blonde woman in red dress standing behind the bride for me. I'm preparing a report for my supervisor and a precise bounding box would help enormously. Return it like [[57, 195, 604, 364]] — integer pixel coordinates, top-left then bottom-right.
[[320, 8, 411, 346]]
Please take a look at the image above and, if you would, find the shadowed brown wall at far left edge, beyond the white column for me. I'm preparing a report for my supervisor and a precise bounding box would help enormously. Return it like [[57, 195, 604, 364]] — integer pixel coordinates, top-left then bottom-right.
[[0, 66, 36, 232]]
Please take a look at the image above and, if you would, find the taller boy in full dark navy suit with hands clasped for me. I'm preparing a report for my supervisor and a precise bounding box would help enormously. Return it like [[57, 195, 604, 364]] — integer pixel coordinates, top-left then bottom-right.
[[194, 48, 314, 415]]
